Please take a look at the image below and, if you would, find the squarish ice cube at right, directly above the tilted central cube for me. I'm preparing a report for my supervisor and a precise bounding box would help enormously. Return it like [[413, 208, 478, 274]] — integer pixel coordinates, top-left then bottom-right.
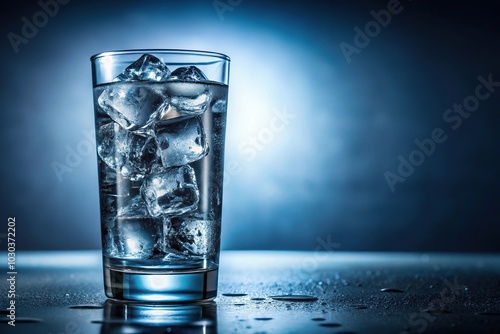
[[155, 116, 209, 167]]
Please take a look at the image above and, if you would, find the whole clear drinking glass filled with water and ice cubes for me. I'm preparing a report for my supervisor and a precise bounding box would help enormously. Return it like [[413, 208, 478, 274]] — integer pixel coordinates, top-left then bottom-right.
[[91, 50, 229, 302]]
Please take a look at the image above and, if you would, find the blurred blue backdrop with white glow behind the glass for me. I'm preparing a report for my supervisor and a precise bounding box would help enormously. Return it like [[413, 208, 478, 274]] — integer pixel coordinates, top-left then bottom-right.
[[0, 0, 500, 251]]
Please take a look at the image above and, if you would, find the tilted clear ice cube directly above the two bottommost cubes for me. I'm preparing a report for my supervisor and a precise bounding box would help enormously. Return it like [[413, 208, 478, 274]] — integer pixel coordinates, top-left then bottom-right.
[[141, 165, 199, 217]]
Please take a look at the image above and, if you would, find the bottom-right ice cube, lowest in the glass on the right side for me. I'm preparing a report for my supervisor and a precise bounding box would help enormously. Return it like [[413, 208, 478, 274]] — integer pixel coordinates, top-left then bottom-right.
[[166, 217, 220, 256]]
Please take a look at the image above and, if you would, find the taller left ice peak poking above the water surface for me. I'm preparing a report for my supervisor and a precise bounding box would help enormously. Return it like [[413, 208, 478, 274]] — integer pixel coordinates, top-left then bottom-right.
[[113, 54, 170, 81]]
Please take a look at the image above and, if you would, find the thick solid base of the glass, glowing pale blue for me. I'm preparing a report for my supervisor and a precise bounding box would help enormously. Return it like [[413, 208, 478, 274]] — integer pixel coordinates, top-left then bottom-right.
[[104, 266, 219, 303]]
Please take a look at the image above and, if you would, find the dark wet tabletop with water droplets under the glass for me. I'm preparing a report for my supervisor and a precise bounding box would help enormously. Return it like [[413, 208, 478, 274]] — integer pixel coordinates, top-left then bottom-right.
[[0, 251, 500, 334]]
